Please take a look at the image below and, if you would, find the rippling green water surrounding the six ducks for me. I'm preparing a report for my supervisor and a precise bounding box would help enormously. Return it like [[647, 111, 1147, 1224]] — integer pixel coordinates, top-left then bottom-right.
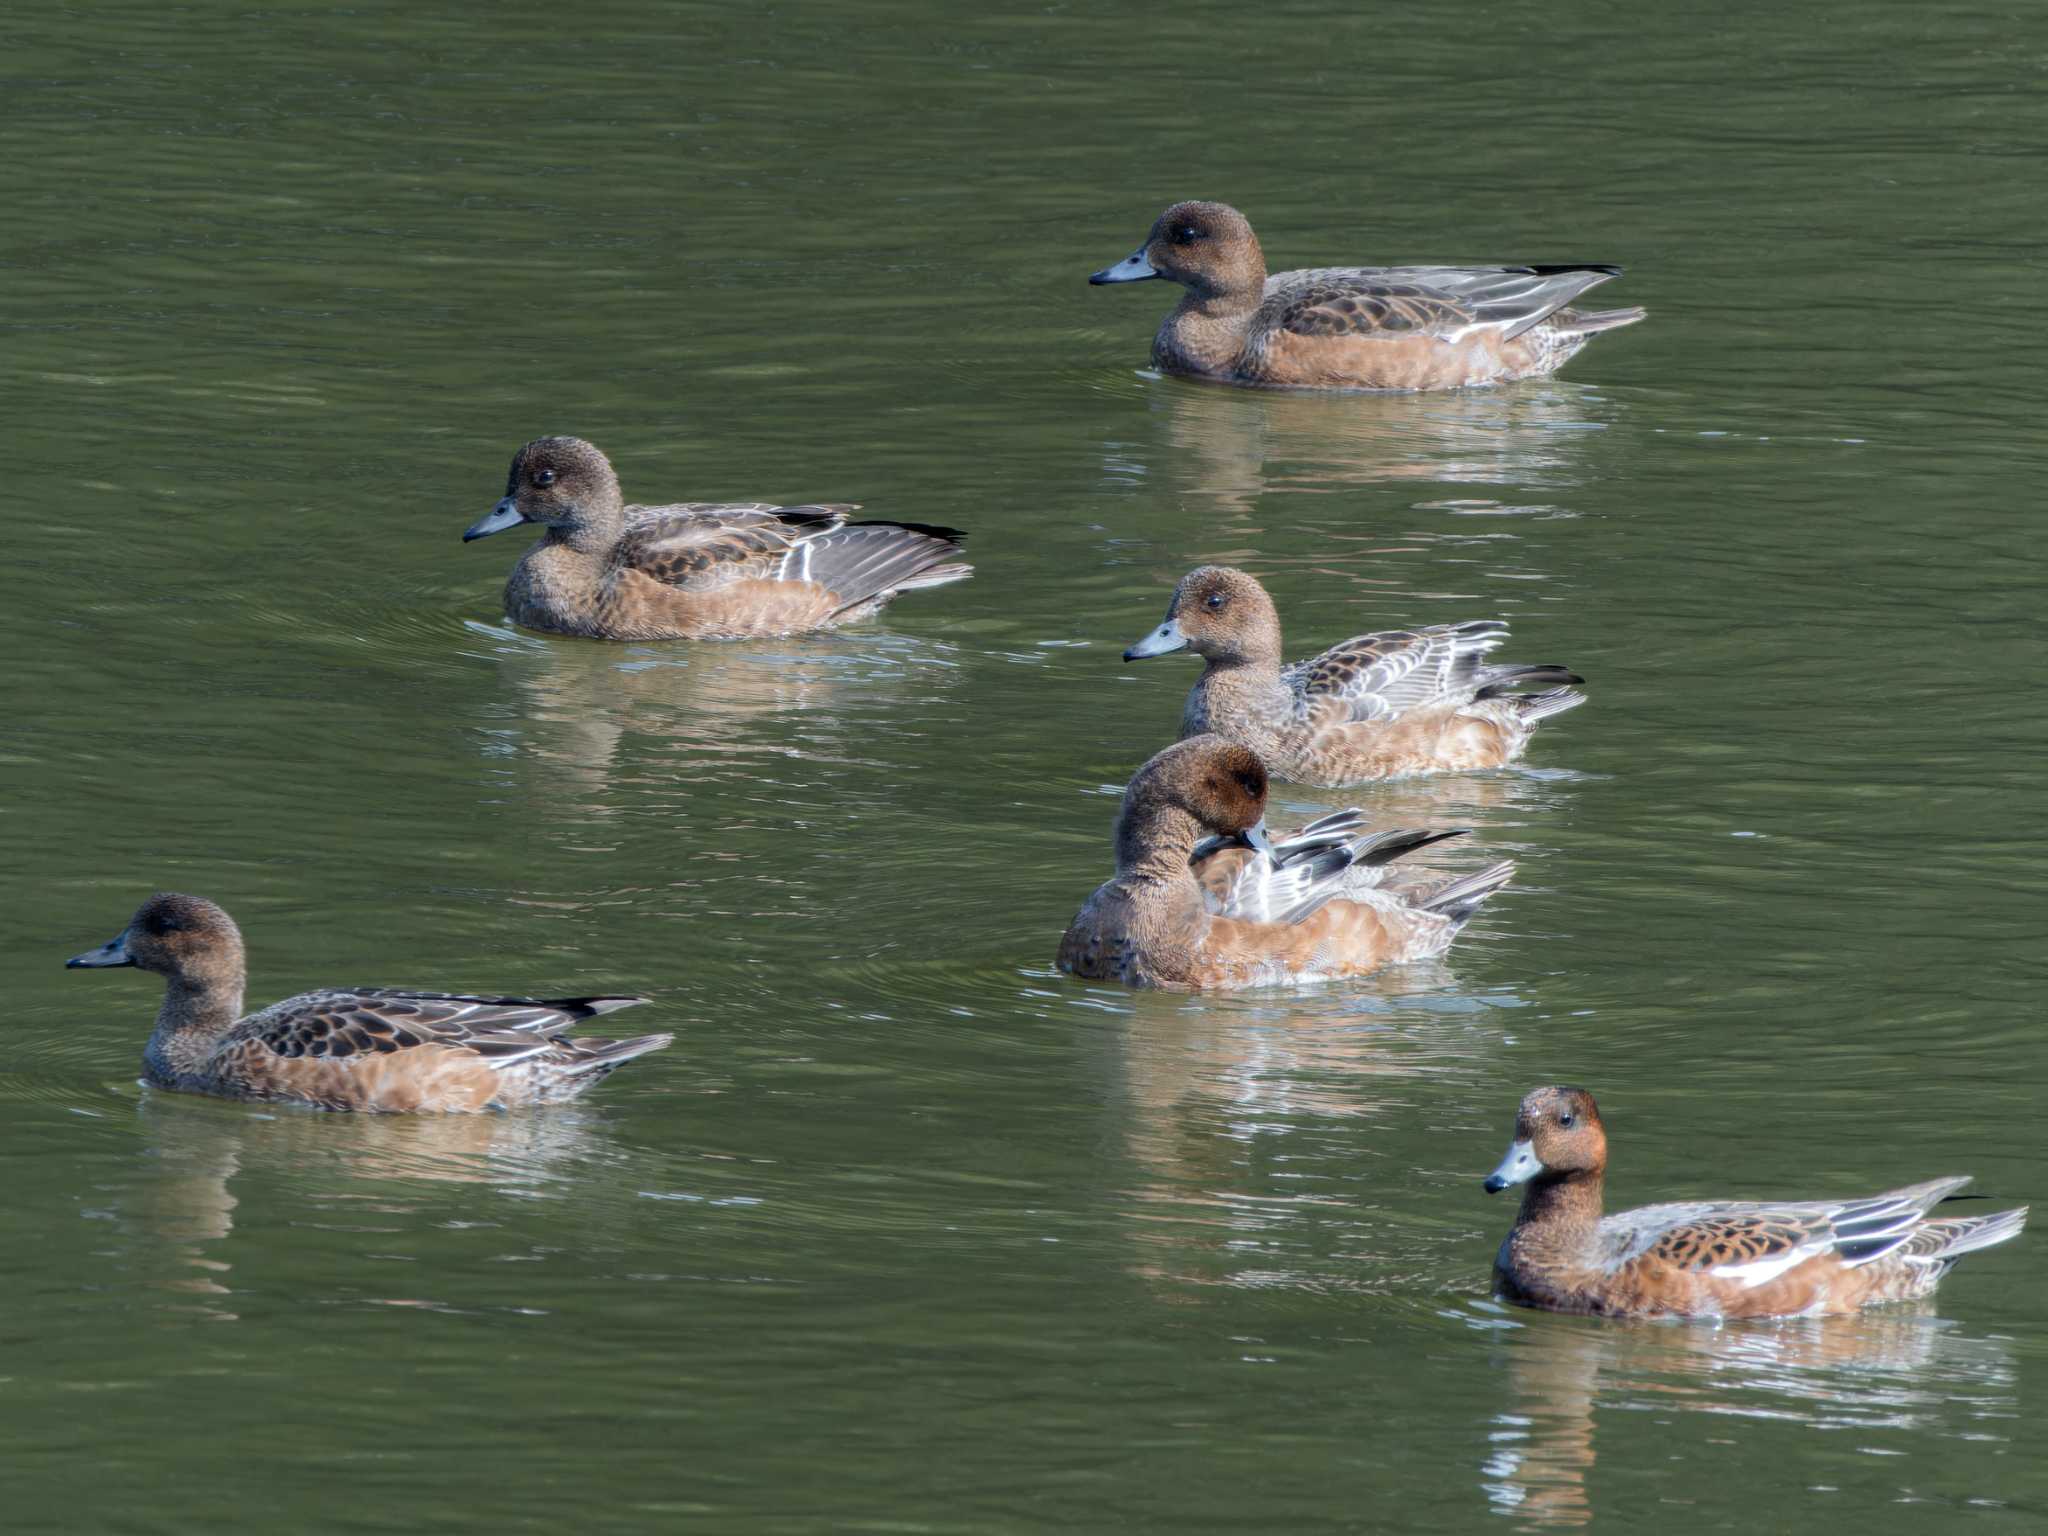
[[0, 0, 2048, 1534]]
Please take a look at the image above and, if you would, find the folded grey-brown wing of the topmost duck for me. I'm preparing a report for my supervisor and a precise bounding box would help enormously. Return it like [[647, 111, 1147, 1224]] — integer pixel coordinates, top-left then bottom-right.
[[1268, 264, 1622, 342]]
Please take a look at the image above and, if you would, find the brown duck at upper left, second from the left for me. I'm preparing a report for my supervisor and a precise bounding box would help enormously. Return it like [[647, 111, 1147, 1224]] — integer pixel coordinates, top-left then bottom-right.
[[463, 438, 975, 641]]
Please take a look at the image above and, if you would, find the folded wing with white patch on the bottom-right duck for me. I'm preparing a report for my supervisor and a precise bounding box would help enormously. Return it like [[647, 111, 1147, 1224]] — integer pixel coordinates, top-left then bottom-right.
[[1602, 1178, 1970, 1288]]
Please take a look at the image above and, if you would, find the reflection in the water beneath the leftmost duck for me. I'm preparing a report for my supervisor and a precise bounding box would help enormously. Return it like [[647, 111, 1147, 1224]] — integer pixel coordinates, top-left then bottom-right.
[[126, 1090, 610, 1321]]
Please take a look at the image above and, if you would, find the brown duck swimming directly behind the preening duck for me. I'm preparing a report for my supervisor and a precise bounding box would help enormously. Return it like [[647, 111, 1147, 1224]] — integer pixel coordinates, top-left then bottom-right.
[[1124, 565, 1585, 788]]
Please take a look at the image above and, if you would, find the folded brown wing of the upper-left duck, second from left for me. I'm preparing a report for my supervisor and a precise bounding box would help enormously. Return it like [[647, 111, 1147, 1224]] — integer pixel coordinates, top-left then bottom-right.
[[625, 502, 973, 608]]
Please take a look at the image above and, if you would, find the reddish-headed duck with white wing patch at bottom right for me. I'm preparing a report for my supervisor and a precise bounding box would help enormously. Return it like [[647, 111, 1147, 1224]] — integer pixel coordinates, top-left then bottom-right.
[[1487, 1085, 2028, 1319]]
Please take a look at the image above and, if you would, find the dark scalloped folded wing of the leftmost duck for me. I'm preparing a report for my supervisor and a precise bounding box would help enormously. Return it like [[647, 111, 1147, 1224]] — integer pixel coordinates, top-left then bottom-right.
[[243, 987, 647, 1067]]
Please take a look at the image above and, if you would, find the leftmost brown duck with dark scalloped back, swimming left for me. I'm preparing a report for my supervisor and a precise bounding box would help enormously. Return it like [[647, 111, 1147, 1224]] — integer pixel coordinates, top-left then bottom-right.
[[66, 891, 676, 1114]]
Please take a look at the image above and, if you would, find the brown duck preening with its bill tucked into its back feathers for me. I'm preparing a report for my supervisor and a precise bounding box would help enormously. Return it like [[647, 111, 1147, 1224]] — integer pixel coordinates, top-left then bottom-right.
[[1059, 735, 1513, 989]]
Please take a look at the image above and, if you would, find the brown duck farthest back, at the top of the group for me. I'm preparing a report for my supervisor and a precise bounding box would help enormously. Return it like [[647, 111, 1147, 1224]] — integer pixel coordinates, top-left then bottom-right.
[[1087, 203, 1645, 389]]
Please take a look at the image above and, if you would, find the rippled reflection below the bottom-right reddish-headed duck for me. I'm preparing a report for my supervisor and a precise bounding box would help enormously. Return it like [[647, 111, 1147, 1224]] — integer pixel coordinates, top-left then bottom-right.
[[1479, 1303, 2019, 1530]]
